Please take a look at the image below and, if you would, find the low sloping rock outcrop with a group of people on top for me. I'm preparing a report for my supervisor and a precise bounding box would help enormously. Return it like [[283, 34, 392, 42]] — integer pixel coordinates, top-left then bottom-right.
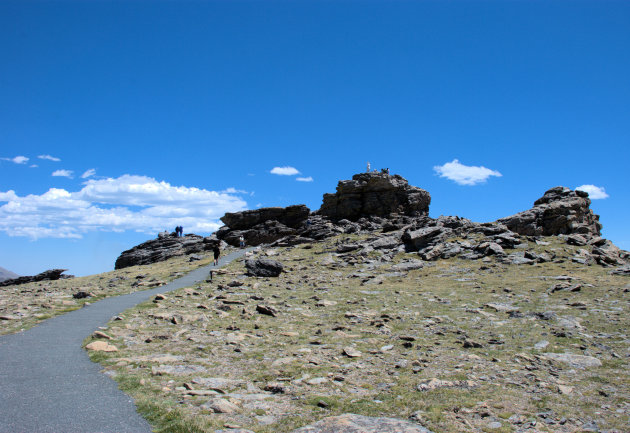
[[114, 234, 220, 269]]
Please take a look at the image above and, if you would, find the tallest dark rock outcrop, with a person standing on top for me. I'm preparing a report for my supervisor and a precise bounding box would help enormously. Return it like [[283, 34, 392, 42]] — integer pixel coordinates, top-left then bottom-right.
[[318, 173, 431, 222]]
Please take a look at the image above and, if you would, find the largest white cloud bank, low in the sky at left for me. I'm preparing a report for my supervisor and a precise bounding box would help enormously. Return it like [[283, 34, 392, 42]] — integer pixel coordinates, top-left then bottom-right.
[[0, 175, 247, 239]]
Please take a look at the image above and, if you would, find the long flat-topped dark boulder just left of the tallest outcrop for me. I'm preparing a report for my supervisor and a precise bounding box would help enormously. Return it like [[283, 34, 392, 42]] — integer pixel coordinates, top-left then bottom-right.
[[221, 204, 311, 230]]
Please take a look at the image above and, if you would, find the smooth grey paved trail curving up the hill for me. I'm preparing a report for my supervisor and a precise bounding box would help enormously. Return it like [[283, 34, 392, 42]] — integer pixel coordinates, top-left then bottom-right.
[[0, 250, 252, 433]]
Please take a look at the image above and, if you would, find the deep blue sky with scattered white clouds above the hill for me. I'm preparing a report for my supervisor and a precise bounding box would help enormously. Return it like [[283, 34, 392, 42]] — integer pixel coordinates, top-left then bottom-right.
[[0, 0, 630, 275]]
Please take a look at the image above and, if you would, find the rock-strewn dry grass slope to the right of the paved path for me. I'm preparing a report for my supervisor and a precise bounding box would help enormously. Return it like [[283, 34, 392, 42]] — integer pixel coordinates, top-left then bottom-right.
[[81, 237, 630, 432]]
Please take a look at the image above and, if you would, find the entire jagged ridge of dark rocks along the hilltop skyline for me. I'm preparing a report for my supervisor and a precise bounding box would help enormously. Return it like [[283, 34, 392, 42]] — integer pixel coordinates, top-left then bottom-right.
[[116, 173, 630, 269]]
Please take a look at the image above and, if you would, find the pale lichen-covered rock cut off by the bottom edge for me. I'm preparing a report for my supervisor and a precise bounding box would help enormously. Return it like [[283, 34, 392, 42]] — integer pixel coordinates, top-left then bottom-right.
[[293, 413, 431, 433]]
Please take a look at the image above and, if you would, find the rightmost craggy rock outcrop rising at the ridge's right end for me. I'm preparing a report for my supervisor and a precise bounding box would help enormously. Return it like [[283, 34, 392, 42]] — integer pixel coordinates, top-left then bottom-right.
[[497, 186, 602, 237]]
